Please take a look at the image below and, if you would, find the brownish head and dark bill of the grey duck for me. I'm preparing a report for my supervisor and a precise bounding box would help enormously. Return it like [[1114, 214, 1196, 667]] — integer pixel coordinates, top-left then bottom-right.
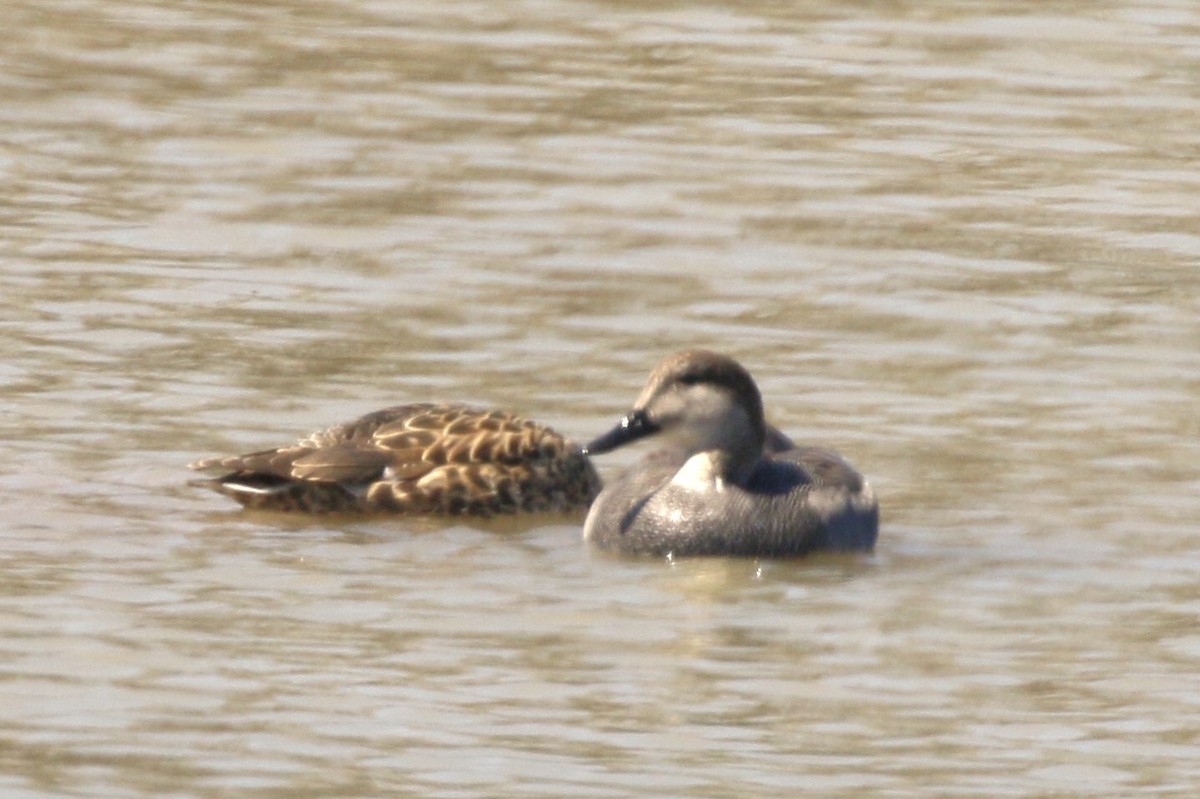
[[584, 349, 767, 476]]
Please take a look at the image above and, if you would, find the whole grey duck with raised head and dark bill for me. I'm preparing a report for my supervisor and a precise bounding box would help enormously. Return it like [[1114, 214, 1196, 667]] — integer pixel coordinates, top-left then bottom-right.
[[583, 349, 880, 558]]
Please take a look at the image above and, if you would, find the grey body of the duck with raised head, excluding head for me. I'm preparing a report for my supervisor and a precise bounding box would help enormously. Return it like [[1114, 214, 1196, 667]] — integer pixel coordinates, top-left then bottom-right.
[[584, 447, 878, 557]]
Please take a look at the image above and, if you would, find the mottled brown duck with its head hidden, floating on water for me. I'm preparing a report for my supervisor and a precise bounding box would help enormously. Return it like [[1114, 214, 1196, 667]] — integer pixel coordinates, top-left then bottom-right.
[[190, 403, 600, 517]]
